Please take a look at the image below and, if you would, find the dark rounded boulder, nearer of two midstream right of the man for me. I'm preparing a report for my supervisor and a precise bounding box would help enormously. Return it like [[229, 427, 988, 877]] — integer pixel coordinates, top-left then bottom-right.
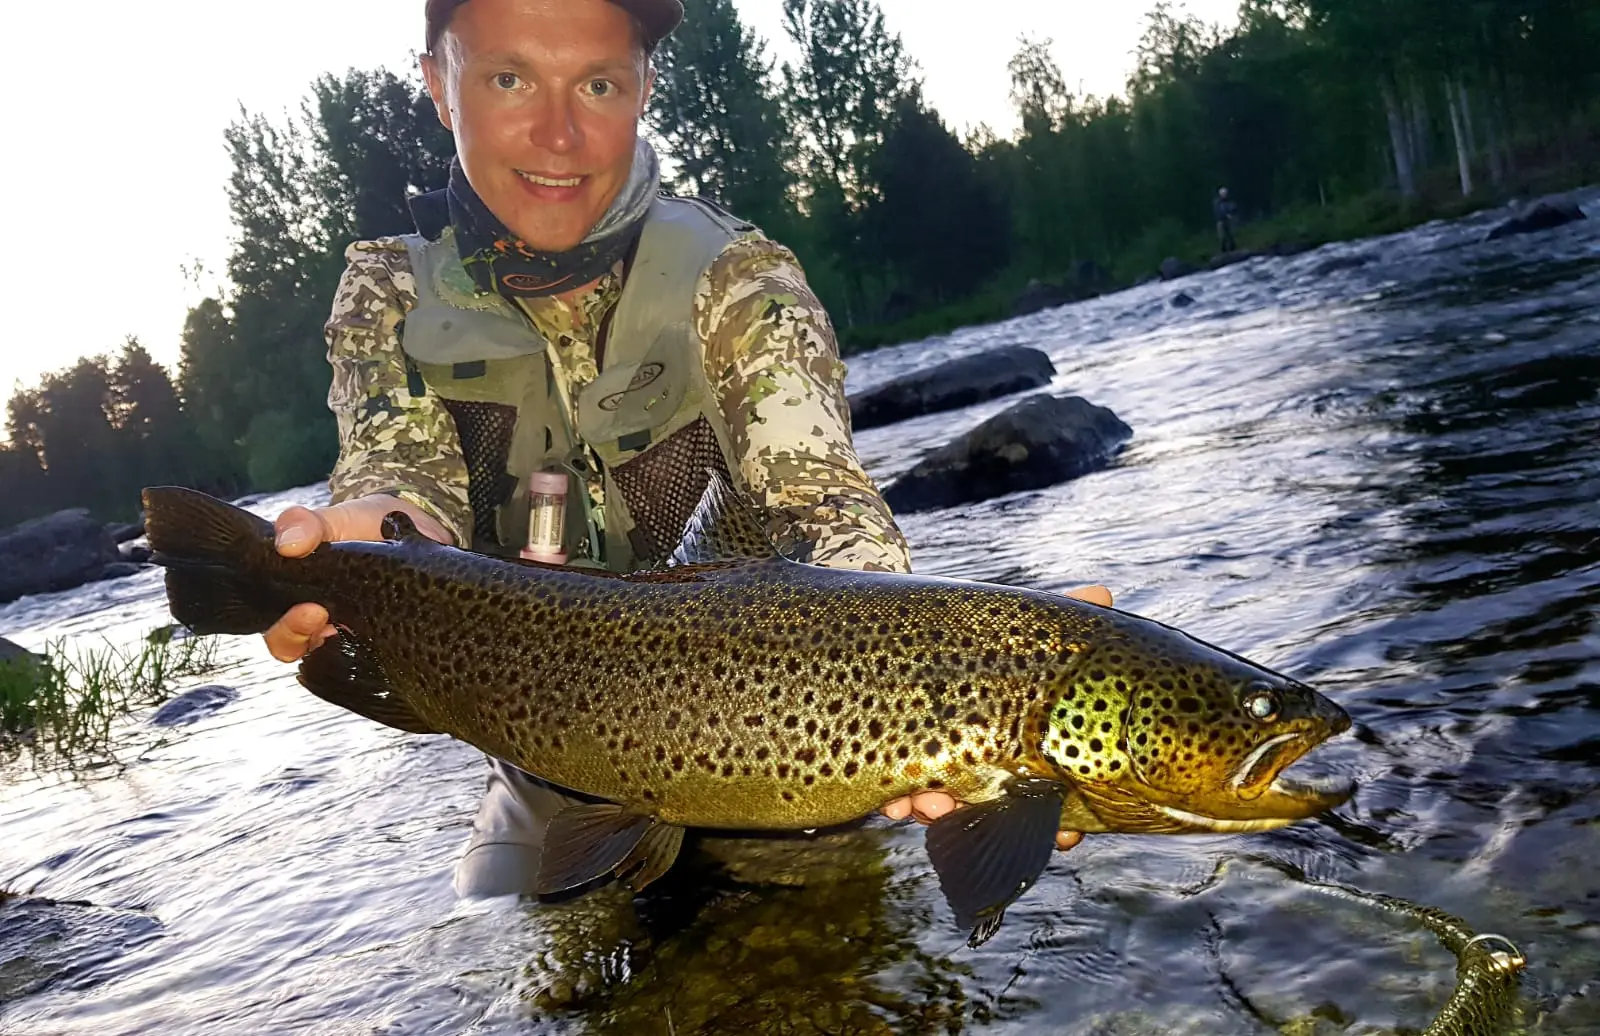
[[883, 395, 1133, 513]]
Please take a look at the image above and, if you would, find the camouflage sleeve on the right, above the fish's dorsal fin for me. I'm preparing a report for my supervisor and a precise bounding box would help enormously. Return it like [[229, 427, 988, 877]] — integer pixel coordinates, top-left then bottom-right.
[[694, 237, 910, 572]]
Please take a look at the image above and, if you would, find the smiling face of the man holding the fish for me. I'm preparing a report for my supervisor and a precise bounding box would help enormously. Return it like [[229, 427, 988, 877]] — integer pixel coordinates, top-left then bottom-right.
[[422, 0, 650, 251]]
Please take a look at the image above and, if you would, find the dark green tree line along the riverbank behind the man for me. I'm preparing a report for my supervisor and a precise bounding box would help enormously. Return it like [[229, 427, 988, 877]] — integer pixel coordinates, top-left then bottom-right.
[[0, 0, 1600, 523]]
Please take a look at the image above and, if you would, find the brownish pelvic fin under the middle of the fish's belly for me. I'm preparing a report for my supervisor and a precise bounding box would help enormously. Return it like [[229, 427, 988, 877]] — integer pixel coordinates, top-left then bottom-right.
[[534, 803, 683, 895]]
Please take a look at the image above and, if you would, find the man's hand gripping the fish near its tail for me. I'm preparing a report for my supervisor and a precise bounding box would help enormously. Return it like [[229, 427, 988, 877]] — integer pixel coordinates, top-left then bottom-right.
[[266, 492, 451, 662]]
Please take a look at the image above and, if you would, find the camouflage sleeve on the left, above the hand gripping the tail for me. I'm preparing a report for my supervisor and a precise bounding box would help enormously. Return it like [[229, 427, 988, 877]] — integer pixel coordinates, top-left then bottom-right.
[[325, 238, 472, 544]]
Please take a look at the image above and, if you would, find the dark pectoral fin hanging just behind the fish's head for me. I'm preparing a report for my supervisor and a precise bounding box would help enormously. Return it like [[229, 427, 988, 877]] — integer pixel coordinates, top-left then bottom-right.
[[928, 779, 1066, 946]]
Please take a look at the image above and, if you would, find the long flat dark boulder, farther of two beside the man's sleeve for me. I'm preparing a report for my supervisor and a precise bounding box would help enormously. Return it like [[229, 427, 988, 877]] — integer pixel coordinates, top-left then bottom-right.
[[850, 345, 1056, 432]]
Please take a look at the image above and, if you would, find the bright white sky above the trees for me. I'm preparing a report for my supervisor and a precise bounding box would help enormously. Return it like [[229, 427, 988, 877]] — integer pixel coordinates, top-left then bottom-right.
[[0, 0, 1237, 401]]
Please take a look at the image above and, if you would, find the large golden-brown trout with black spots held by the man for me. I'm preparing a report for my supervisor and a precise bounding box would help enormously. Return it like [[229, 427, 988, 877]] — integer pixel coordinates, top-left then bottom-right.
[[144, 480, 1350, 945]]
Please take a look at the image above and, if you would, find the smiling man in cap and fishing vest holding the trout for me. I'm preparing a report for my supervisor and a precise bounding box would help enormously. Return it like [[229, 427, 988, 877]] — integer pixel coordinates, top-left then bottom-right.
[[267, 0, 1109, 895]]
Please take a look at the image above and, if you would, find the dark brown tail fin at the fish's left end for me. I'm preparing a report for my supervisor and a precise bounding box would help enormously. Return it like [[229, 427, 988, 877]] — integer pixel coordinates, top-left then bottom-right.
[[142, 486, 294, 633]]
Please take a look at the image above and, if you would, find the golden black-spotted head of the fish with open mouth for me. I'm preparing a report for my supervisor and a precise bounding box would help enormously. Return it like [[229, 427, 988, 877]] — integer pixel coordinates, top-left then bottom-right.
[[1043, 620, 1354, 831]]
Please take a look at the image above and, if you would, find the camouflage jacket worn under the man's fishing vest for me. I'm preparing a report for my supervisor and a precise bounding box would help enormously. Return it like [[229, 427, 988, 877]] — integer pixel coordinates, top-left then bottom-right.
[[326, 228, 910, 572]]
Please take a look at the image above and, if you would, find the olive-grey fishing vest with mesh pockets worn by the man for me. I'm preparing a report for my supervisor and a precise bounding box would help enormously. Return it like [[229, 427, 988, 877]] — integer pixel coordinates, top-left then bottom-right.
[[400, 197, 754, 571]]
